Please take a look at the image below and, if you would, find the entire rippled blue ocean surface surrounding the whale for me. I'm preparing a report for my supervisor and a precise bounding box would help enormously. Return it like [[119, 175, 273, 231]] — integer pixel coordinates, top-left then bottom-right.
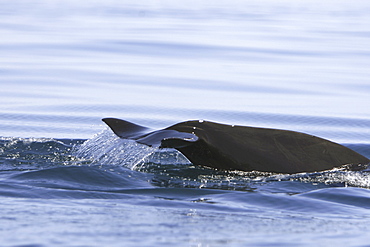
[[0, 0, 370, 247]]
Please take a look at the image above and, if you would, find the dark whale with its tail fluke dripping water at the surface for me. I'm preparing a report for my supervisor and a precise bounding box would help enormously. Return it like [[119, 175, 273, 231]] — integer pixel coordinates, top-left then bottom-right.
[[102, 118, 370, 174]]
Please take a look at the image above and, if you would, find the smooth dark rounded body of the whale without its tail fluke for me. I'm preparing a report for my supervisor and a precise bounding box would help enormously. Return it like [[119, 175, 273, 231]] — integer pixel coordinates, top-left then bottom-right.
[[167, 121, 370, 173]]
